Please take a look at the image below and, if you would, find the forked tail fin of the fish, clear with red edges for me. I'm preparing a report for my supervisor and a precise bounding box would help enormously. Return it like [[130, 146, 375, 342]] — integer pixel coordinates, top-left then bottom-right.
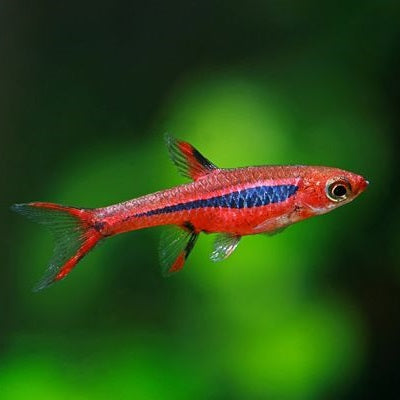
[[11, 202, 102, 291]]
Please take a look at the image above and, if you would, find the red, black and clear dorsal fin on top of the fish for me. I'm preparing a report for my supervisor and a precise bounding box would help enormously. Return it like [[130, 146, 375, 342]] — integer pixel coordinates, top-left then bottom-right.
[[165, 134, 217, 180]]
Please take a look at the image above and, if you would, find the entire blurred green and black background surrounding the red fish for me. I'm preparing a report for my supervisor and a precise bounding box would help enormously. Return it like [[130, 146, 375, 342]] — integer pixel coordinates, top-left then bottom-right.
[[0, 0, 400, 400]]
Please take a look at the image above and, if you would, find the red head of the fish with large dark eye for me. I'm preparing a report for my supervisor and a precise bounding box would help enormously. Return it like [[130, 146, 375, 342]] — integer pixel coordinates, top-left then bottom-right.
[[300, 167, 369, 215]]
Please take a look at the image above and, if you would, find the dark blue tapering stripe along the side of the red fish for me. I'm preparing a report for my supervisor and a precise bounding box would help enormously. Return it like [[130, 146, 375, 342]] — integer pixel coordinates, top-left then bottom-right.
[[135, 185, 298, 217]]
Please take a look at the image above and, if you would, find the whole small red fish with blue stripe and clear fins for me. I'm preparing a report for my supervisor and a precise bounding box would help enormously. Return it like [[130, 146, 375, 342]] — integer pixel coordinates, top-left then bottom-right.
[[11, 134, 369, 291]]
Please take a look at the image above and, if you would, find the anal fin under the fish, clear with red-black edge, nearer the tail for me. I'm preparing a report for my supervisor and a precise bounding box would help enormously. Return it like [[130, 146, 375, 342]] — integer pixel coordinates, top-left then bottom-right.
[[159, 225, 198, 276]]
